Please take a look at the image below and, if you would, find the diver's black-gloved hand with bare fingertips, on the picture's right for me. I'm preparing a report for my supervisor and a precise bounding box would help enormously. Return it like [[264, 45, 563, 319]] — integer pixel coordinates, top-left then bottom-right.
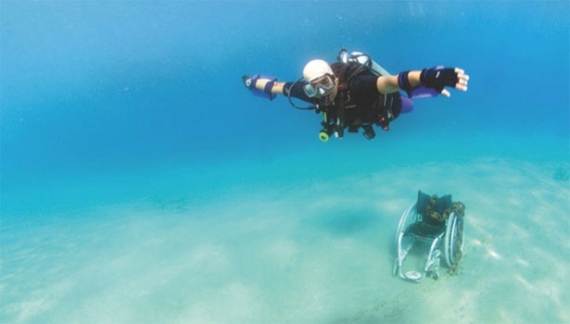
[[420, 66, 469, 97]]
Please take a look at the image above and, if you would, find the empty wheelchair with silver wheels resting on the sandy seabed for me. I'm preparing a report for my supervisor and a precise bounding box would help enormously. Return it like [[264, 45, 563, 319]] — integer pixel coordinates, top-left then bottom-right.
[[392, 191, 465, 282]]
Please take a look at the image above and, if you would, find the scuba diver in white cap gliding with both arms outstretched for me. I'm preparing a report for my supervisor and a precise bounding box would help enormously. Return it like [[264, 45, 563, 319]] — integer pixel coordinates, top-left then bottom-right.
[[242, 48, 469, 142]]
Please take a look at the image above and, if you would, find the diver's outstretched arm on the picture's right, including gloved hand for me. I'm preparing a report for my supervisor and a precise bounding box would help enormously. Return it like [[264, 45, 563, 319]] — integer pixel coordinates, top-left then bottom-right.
[[376, 67, 469, 97]]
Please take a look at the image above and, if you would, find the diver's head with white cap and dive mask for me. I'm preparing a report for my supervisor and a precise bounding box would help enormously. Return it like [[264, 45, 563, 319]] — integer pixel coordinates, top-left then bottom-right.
[[303, 60, 336, 98]]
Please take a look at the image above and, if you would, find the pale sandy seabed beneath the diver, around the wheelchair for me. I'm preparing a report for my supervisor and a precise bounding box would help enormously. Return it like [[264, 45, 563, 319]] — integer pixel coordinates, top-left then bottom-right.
[[0, 150, 570, 323]]
